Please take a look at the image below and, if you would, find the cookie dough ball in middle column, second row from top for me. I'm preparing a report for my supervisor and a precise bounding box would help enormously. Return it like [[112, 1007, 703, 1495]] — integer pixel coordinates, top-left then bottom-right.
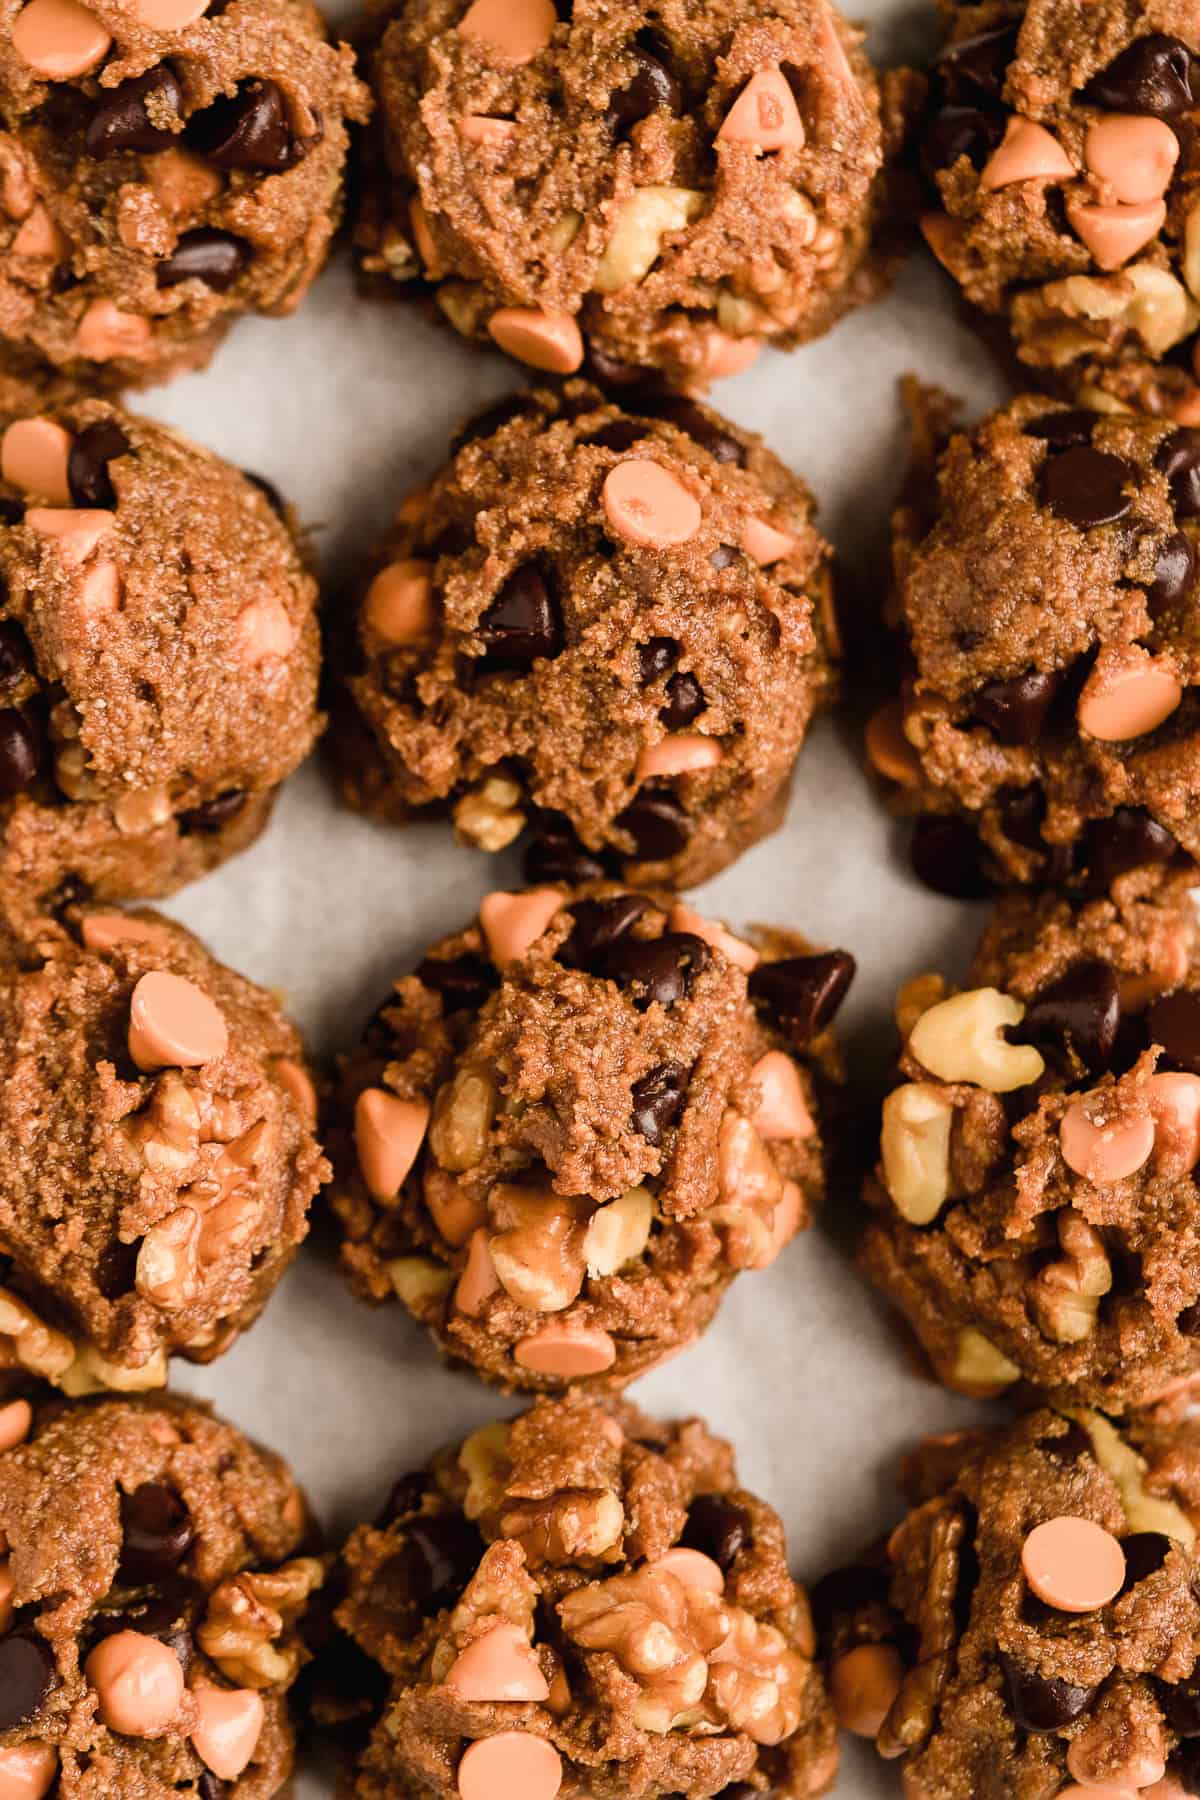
[[332, 382, 838, 886]]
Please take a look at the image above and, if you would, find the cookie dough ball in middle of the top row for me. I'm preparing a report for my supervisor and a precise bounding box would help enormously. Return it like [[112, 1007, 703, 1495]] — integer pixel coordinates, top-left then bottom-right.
[[347, 0, 900, 385]]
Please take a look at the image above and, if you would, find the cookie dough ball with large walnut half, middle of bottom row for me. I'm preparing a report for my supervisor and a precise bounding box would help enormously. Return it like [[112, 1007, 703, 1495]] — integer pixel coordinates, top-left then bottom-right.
[[323, 1395, 837, 1800]]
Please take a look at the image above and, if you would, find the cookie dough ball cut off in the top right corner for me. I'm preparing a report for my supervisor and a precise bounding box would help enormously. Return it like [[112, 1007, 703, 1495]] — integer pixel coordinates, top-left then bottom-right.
[[921, 0, 1200, 414]]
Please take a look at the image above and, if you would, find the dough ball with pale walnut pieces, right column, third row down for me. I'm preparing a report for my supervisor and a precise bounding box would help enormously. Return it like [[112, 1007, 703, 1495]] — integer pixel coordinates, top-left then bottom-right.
[[862, 891, 1200, 1411]]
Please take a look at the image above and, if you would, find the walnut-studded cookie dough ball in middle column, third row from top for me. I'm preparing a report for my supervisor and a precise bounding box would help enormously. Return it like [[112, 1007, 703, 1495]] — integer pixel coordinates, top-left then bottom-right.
[[329, 884, 855, 1388]]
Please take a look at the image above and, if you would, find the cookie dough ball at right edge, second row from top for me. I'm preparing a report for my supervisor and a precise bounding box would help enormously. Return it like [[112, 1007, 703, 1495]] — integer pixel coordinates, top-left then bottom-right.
[[867, 396, 1200, 896]]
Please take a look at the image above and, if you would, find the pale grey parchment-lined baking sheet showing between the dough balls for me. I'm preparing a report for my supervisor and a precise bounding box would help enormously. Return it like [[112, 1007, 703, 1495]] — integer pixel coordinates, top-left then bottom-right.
[[139, 0, 1021, 1778]]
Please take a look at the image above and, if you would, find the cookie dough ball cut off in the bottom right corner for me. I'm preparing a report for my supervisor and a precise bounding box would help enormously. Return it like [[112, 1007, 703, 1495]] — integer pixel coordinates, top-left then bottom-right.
[[813, 1408, 1200, 1800]]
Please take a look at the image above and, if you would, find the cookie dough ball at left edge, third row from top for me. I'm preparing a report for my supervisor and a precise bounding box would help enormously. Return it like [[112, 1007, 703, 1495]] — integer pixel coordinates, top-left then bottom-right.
[[0, 911, 329, 1393]]
